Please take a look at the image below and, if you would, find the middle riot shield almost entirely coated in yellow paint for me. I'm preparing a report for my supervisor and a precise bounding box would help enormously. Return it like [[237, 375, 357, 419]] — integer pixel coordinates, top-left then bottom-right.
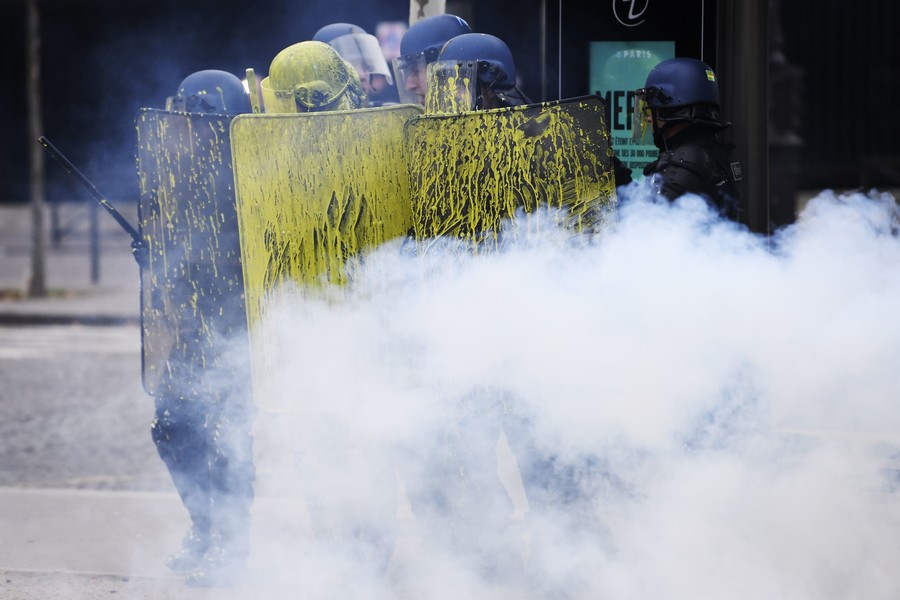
[[231, 105, 421, 409]]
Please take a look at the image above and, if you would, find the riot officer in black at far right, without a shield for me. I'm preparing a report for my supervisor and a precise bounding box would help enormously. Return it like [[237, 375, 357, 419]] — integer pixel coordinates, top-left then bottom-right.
[[634, 58, 741, 221]]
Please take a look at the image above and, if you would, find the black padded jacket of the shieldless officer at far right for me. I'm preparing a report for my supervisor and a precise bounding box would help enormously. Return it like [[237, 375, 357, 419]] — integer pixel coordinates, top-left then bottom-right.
[[644, 124, 741, 221]]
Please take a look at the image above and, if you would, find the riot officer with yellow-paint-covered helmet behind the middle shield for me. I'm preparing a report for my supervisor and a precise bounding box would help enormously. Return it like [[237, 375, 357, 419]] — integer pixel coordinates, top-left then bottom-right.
[[255, 34, 397, 578]]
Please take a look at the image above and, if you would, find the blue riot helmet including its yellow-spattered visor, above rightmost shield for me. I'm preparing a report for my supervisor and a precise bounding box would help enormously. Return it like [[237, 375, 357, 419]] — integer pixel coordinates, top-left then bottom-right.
[[429, 33, 531, 112]]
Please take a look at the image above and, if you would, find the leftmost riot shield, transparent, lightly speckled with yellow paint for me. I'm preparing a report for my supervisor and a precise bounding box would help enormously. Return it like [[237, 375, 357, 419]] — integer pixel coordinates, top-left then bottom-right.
[[135, 109, 249, 400]]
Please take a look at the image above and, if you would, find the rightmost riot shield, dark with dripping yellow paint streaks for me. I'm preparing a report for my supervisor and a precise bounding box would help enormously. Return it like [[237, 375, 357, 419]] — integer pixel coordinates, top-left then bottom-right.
[[406, 96, 616, 251]]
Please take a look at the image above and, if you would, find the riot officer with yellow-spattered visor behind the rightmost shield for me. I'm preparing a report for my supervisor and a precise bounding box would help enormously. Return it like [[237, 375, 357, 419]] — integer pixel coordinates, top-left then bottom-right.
[[426, 33, 624, 597]]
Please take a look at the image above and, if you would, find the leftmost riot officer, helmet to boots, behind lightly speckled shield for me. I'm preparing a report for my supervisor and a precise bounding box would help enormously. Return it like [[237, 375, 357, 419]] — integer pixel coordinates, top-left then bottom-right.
[[134, 70, 255, 587]]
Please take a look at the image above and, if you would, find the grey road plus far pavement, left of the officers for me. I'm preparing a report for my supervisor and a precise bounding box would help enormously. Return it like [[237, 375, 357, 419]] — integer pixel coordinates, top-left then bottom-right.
[[0, 204, 316, 600]]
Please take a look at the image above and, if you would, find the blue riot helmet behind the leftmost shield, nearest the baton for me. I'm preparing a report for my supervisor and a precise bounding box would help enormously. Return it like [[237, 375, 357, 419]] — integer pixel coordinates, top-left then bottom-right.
[[167, 69, 251, 115]]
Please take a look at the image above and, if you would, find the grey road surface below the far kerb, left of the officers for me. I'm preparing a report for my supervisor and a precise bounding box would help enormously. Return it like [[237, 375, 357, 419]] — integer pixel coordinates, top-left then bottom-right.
[[0, 324, 338, 599]]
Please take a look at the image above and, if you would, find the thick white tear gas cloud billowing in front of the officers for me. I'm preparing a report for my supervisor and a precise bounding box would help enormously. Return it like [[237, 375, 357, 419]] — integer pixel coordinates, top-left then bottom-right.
[[234, 184, 900, 600]]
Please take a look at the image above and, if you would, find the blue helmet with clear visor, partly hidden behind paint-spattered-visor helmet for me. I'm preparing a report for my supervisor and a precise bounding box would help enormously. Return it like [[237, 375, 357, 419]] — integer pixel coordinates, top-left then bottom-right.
[[394, 14, 472, 105]]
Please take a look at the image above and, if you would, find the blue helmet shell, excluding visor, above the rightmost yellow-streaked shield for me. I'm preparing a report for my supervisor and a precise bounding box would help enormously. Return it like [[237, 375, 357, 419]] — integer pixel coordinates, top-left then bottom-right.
[[436, 33, 531, 108]]
